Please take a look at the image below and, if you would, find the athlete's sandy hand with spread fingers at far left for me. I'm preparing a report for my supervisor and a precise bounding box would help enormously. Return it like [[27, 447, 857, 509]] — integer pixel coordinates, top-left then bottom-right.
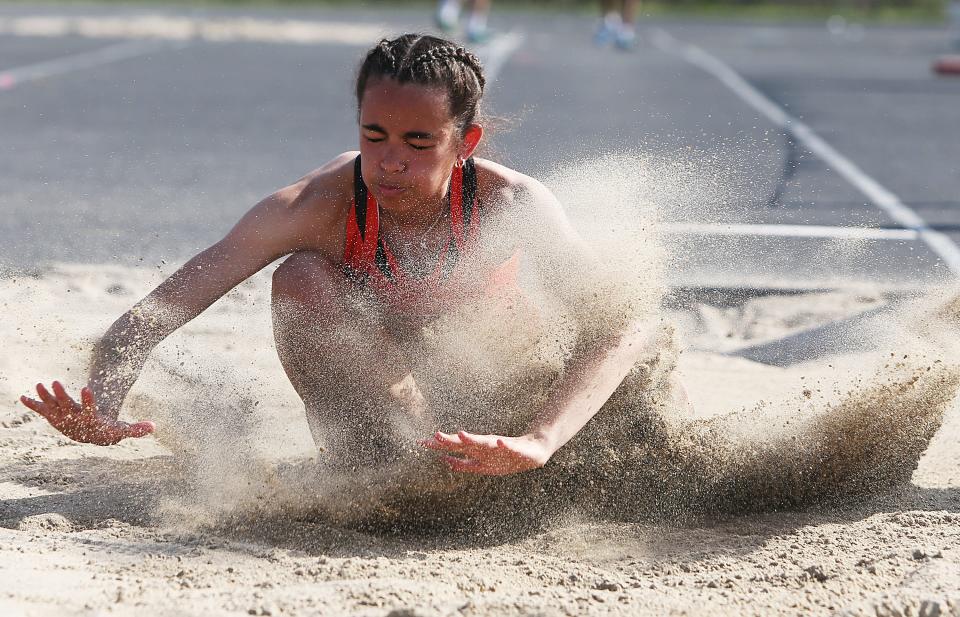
[[20, 381, 154, 446]]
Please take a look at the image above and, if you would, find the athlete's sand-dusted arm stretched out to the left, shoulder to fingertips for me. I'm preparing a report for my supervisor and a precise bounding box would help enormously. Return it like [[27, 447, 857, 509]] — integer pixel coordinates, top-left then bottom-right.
[[21, 157, 352, 445]]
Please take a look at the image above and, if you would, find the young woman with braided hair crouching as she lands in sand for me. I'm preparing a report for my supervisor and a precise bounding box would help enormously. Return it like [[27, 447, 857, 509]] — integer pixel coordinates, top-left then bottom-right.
[[21, 34, 656, 475]]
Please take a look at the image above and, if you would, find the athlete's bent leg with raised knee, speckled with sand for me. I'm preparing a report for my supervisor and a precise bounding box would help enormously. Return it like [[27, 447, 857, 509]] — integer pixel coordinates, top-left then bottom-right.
[[272, 252, 434, 463]]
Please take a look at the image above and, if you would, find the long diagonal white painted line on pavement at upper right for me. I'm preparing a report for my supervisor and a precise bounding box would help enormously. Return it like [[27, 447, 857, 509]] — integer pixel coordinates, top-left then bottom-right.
[[652, 28, 960, 275]]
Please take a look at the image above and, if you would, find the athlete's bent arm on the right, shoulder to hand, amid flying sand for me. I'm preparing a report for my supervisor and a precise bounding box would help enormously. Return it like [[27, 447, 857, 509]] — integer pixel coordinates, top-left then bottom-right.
[[423, 180, 651, 475]]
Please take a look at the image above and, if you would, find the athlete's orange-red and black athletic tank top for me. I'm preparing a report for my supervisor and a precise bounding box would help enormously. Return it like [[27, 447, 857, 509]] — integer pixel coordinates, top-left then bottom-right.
[[343, 156, 519, 315]]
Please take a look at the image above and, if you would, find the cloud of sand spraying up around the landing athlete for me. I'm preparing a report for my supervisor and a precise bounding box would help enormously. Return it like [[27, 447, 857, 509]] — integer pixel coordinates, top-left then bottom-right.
[[5, 153, 960, 526]]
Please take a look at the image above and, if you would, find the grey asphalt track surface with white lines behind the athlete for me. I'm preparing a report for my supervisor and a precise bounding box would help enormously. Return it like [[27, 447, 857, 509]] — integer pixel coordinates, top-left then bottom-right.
[[0, 5, 960, 287]]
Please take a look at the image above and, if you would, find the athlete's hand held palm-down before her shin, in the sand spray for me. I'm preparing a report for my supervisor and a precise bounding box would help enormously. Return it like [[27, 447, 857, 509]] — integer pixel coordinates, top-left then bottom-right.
[[420, 431, 553, 476]]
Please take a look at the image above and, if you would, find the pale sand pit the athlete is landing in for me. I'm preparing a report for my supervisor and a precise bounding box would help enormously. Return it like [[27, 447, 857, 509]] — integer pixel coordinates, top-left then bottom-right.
[[0, 266, 960, 615]]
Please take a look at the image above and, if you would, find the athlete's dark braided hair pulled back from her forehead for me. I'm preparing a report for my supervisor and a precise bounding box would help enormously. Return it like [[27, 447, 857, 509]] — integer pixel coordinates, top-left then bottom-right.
[[356, 34, 486, 131]]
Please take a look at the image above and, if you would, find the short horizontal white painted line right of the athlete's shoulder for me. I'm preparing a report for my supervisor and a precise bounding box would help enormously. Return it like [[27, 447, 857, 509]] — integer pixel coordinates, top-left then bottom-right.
[[659, 223, 920, 241]]
